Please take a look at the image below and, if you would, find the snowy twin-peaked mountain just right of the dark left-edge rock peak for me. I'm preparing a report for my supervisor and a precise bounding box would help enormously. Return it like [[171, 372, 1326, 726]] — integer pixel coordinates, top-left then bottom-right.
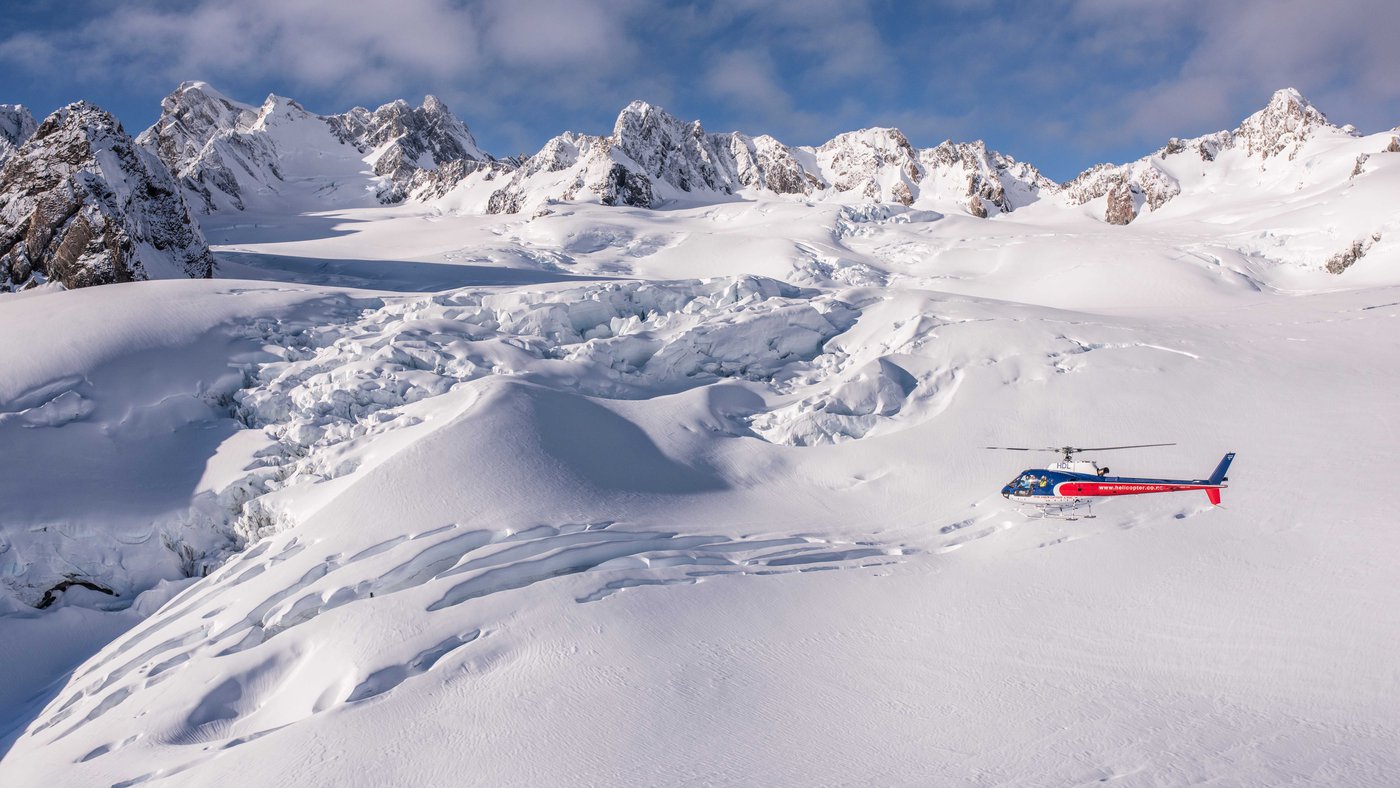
[[137, 83, 512, 213]]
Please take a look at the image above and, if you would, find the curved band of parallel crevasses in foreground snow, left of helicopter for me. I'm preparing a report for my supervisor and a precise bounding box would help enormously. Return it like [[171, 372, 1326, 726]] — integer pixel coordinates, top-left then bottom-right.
[[19, 512, 906, 784]]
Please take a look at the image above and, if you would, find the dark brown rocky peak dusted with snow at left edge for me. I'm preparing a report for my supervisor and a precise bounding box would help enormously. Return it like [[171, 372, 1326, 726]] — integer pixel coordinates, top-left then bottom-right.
[[0, 102, 214, 290]]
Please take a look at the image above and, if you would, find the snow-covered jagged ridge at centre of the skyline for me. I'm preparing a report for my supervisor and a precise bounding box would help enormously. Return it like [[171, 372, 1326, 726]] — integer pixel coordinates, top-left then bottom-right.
[[487, 101, 1056, 216]]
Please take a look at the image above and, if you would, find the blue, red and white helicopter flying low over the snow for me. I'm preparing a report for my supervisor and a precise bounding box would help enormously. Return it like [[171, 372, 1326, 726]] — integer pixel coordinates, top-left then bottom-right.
[[984, 444, 1235, 519]]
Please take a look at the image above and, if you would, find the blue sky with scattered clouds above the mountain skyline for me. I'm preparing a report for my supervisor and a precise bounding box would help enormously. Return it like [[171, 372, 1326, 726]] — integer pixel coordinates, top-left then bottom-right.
[[0, 0, 1400, 179]]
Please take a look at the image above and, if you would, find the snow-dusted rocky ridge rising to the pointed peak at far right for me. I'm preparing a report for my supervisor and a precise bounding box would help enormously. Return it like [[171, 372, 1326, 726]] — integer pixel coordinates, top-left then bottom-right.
[[1061, 88, 1352, 224]]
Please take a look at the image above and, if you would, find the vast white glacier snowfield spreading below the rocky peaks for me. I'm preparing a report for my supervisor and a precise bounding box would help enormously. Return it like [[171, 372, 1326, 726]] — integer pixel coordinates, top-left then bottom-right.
[[0, 87, 1400, 787]]
